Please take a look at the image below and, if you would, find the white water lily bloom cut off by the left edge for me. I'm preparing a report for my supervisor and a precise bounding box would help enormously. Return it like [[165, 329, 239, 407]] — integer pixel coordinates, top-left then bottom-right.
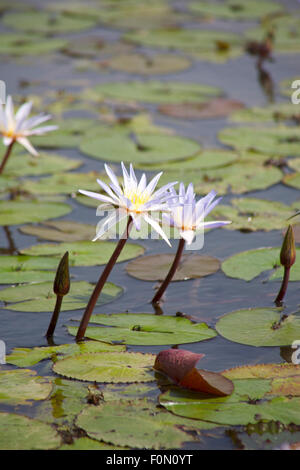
[[0, 96, 58, 156]]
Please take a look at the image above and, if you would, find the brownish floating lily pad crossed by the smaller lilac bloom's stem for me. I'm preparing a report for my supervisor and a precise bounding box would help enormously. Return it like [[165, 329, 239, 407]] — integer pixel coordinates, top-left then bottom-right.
[[126, 253, 220, 281]]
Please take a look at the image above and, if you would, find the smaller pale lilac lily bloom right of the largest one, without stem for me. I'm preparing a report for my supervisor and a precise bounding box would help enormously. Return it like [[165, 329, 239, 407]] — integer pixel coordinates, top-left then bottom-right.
[[164, 183, 231, 245]]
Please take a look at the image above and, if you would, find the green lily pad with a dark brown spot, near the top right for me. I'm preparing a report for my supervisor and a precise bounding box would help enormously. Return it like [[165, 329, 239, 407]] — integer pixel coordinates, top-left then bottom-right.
[[124, 28, 243, 63]]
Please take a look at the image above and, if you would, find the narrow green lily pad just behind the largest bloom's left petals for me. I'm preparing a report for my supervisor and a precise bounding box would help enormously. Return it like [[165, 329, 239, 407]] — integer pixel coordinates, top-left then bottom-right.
[[22, 171, 107, 196]]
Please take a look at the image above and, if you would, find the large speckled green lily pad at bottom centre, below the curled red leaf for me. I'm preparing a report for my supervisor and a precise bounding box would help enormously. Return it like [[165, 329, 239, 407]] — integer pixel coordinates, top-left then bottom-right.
[[76, 400, 196, 449]]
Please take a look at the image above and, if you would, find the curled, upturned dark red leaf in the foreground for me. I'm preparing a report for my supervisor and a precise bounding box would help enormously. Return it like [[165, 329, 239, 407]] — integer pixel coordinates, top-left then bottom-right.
[[154, 349, 233, 397]]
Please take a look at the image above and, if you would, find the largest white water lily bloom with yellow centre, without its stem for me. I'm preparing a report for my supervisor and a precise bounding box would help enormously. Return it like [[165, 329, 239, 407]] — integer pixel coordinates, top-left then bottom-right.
[[79, 162, 176, 246]]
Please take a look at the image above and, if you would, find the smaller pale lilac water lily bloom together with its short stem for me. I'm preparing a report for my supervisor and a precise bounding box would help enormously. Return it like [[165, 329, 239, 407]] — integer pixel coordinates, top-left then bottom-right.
[[152, 183, 231, 305]]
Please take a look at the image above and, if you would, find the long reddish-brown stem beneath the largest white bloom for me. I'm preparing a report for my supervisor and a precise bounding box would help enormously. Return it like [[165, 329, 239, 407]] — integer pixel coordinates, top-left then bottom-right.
[[76, 216, 132, 341]]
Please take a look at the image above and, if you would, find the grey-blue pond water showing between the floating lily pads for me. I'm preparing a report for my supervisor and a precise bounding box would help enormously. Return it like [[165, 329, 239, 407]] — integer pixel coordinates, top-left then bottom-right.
[[0, 0, 300, 449]]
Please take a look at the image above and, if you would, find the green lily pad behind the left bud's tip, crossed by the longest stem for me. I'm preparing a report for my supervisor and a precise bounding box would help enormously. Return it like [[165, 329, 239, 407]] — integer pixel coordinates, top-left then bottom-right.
[[21, 241, 144, 266]]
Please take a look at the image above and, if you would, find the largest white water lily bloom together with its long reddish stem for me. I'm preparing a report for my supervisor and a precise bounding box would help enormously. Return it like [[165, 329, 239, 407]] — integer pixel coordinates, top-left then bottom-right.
[[76, 163, 176, 341]]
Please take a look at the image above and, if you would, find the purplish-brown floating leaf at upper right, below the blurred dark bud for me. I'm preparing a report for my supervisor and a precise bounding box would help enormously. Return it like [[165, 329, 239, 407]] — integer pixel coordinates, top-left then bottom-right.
[[158, 98, 244, 119]]
